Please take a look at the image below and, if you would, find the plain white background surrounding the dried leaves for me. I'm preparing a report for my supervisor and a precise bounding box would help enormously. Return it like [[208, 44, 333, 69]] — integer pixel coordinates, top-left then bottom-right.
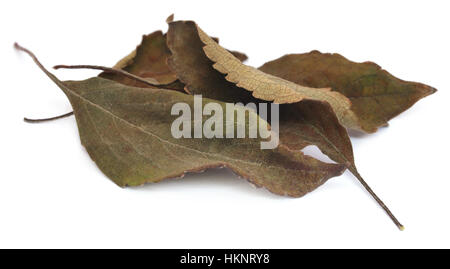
[[0, 0, 450, 248]]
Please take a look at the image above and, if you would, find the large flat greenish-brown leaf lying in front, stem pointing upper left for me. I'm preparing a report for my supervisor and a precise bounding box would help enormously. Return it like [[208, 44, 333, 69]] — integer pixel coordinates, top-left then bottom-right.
[[16, 45, 345, 197]]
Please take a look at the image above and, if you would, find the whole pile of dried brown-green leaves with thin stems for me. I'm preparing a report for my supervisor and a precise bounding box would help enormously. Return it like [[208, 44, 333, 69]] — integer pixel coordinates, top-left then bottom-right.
[[16, 16, 436, 229]]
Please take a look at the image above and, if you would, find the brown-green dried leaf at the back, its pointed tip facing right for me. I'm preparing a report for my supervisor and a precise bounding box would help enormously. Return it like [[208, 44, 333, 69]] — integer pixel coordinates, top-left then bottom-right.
[[259, 51, 436, 132]]
